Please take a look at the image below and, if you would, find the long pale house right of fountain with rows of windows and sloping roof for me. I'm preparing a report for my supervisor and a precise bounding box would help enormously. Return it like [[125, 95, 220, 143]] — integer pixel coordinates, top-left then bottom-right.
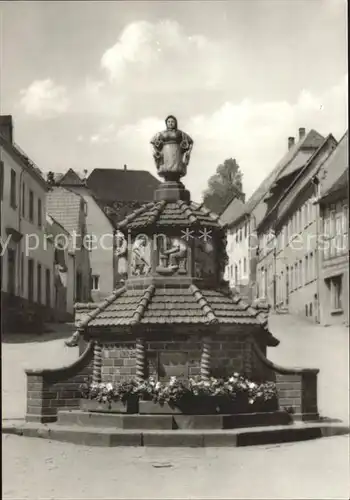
[[257, 135, 337, 322]]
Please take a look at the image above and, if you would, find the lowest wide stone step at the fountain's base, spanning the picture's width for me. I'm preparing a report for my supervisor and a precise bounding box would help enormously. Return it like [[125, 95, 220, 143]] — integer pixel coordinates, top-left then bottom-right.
[[2, 422, 349, 447]]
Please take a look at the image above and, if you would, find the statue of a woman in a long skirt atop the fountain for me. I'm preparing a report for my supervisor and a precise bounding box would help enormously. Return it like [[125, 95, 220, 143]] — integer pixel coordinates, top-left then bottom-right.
[[151, 115, 193, 180]]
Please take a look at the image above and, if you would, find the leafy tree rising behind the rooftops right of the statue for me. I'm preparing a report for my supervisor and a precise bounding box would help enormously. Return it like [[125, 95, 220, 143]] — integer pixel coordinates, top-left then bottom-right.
[[203, 158, 244, 215]]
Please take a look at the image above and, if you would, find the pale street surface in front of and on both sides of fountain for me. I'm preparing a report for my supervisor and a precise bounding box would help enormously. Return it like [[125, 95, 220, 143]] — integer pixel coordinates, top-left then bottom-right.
[[2, 315, 350, 500]]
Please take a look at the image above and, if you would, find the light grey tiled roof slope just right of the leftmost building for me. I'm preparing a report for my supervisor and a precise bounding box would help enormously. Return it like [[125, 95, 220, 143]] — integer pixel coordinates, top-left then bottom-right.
[[46, 186, 83, 234]]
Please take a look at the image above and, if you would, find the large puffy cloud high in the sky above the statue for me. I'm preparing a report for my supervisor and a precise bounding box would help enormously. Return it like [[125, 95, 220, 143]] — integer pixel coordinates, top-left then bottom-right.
[[101, 20, 224, 92]]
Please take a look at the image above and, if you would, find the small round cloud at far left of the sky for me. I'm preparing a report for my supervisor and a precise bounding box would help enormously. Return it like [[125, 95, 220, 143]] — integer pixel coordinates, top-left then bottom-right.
[[20, 78, 70, 118]]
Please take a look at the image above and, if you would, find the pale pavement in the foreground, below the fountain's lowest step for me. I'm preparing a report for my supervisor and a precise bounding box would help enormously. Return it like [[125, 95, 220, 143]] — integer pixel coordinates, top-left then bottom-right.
[[2, 435, 350, 500]]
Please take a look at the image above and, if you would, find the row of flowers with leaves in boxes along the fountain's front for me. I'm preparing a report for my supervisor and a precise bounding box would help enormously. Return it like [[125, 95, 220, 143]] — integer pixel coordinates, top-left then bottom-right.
[[81, 373, 276, 405]]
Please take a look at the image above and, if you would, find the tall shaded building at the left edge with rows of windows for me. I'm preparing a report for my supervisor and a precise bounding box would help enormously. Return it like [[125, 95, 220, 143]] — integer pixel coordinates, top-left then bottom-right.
[[0, 116, 54, 331]]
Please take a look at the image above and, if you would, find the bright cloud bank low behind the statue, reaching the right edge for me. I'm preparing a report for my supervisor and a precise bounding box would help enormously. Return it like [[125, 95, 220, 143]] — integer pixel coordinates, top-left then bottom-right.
[[87, 75, 348, 200]]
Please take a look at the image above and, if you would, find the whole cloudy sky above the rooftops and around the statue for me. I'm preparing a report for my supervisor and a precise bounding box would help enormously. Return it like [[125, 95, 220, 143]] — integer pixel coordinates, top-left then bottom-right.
[[0, 0, 348, 201]]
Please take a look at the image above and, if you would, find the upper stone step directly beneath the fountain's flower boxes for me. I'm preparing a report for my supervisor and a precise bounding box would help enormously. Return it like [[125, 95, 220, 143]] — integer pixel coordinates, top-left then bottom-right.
[[57, 410, 293, 430]]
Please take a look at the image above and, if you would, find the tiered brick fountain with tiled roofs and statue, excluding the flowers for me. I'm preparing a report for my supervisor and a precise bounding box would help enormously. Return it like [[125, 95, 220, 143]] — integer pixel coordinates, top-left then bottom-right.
[[21, 116, 328, 444]]
